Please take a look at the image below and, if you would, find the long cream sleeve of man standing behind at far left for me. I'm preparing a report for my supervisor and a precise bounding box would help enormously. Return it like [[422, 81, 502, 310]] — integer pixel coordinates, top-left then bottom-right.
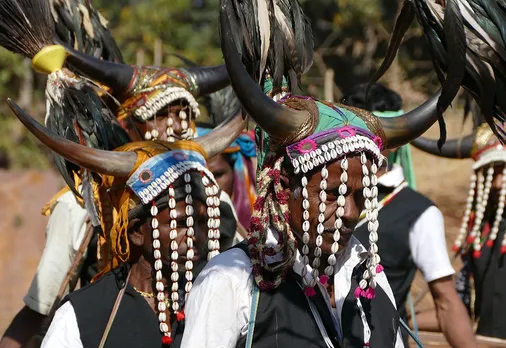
[[24, 191, 88, 315]]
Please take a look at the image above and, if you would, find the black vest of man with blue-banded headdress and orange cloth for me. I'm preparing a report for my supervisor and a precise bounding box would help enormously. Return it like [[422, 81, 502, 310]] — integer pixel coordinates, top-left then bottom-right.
[[62, 267, 184, 348]]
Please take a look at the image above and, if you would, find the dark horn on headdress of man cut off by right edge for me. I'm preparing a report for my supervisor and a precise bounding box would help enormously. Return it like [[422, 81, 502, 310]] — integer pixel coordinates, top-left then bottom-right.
[[411, 133, 475, 158]]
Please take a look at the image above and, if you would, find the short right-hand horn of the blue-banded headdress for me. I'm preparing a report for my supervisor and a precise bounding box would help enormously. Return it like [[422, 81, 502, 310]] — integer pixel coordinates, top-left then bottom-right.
[[193, 107, 247, 158]]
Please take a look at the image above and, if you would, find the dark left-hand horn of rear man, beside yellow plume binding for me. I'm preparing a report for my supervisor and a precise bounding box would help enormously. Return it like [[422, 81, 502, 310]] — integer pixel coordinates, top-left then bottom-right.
[[55, 40, 135, 95]]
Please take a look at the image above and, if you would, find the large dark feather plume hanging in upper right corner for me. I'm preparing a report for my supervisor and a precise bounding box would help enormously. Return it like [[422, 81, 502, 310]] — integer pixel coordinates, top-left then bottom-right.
[[372, 0, 506, 146]]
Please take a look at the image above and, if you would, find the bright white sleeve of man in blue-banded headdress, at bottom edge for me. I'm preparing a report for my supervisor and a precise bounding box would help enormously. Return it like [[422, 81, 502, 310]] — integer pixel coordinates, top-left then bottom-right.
[[41, 301, 83, 348]]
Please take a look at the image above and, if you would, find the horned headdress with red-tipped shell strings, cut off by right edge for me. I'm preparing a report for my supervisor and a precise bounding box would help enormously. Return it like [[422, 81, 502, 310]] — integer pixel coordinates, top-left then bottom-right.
[[413, 123, 506, 258]]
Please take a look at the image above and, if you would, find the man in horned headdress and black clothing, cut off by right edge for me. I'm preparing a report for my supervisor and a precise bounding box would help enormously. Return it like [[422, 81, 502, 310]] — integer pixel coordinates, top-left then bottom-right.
[[416, 124, 506, 339]]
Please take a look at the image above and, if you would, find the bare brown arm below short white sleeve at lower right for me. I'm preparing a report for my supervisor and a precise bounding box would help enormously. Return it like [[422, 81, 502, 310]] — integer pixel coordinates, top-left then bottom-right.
[[429, 276, 476, 348]]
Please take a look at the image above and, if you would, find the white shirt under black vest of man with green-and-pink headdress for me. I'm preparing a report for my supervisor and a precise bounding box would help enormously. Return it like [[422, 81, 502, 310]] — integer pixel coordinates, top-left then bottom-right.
[[181, 230, 404, 348]]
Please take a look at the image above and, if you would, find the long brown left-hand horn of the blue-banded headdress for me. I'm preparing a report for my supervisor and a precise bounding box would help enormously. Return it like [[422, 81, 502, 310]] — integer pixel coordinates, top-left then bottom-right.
[[7, 98, 137, 177]]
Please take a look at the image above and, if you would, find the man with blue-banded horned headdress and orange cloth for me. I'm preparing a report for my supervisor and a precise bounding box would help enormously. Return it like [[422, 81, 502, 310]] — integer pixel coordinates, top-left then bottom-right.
[[9, 97, 244, 347]]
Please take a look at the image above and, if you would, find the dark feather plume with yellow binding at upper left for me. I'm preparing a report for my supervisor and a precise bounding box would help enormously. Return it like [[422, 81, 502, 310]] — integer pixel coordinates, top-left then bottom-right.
[[0, 0, 129, 226]]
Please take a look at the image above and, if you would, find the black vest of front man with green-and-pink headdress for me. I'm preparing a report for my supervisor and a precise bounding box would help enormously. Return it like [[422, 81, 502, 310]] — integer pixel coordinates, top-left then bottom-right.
[[236, 243, 399, 348]]
